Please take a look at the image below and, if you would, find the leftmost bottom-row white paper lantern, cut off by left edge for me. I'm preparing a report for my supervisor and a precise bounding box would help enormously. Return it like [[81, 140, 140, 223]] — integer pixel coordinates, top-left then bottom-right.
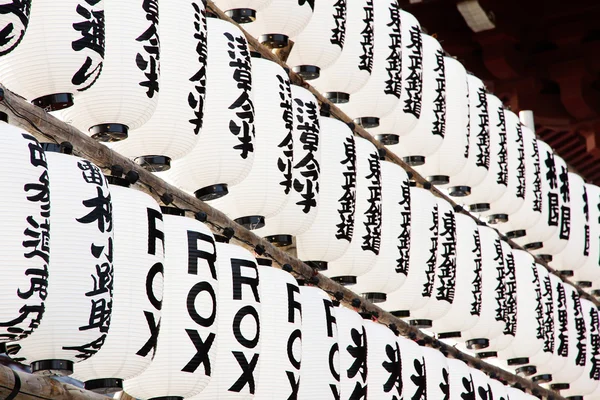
[[0, 119, 49, 345]]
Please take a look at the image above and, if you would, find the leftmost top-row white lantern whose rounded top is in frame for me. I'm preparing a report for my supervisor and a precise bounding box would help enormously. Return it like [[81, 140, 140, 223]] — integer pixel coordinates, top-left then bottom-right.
[[369, 10, 423, 142]]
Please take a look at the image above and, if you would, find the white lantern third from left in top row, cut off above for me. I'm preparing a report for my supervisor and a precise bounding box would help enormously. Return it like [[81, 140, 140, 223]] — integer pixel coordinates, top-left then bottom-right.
[[287, 0, 347, 80]]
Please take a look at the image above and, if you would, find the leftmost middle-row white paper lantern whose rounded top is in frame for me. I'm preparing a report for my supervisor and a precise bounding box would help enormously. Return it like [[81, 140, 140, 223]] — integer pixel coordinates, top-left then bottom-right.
[[169, 18, 255, 201]]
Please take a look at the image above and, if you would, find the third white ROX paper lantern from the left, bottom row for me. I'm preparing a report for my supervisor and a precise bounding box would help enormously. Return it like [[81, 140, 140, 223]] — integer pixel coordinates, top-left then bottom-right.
[[195, 243, 262, 400]]
